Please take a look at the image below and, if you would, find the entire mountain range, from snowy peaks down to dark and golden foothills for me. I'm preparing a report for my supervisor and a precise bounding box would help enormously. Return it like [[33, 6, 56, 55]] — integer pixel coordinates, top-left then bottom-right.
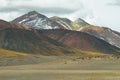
[[0, 11, 120, 60]]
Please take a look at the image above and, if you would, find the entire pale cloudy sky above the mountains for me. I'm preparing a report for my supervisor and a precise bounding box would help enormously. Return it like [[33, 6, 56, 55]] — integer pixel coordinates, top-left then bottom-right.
[[0, 0, 120, 32]]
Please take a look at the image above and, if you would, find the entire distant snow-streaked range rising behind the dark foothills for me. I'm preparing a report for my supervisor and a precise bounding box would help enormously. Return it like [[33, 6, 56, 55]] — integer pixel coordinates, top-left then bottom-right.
[[11, 11, 120, 48]]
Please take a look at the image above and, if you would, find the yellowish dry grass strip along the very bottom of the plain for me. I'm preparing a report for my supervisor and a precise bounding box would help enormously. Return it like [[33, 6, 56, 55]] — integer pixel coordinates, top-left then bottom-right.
[[0, 70, 120, 80]]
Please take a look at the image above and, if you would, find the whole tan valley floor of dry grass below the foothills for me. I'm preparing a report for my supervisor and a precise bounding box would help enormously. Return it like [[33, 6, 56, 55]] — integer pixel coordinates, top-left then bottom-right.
[[0, 57, 120, 80]]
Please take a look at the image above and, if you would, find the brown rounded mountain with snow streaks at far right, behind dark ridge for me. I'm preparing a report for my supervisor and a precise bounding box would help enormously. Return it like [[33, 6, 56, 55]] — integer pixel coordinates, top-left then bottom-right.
[[80, 25, 120, 48]]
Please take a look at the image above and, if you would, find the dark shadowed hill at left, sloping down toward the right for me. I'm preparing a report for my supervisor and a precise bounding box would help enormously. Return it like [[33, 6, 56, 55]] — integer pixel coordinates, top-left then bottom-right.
[[0, 21, 85, 55]]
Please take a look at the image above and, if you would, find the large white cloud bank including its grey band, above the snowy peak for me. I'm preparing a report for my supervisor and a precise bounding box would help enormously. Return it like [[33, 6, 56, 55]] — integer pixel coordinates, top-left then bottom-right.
[[0, 0, 87, 19]]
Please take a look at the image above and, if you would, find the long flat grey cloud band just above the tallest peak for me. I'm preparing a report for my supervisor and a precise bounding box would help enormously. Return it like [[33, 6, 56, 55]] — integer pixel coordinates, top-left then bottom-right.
[[0, 6, 77, 14]]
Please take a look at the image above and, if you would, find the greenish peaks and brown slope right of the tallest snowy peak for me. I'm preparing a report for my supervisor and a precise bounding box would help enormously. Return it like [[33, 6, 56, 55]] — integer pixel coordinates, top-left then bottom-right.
[[50, 17, 120, 48]]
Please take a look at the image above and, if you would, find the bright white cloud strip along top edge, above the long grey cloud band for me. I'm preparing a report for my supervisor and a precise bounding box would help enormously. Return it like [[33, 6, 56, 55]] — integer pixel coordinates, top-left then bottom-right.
[[6, 0, 83, 9]]
